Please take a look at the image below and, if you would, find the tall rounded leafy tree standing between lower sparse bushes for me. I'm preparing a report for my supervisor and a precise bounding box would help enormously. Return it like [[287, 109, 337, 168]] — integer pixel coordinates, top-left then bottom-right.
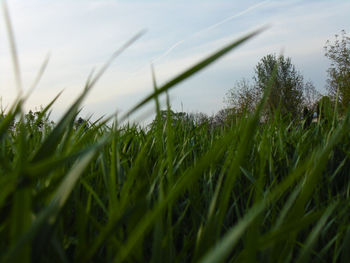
[[254, 54, 305, 117]]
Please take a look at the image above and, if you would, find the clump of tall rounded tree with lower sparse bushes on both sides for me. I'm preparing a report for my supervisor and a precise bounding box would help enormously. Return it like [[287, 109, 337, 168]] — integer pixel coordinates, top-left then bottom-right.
[[224, 54, 320, 118]]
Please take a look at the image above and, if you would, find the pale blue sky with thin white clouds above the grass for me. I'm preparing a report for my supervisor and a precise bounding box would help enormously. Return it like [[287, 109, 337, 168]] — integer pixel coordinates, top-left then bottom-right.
[[0, 0, 350, 122]]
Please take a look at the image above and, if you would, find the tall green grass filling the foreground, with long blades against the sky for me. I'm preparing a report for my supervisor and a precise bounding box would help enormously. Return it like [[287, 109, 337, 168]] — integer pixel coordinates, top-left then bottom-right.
[[0, 26, 350, 262]]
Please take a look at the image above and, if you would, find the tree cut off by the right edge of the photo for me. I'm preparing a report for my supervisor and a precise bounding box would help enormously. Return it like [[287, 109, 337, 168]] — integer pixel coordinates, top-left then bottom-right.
[[324, 30, 350, 112]]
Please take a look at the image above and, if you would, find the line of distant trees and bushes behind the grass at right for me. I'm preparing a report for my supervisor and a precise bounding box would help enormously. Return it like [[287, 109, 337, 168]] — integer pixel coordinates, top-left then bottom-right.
[[159, 30, 350, 129]]
